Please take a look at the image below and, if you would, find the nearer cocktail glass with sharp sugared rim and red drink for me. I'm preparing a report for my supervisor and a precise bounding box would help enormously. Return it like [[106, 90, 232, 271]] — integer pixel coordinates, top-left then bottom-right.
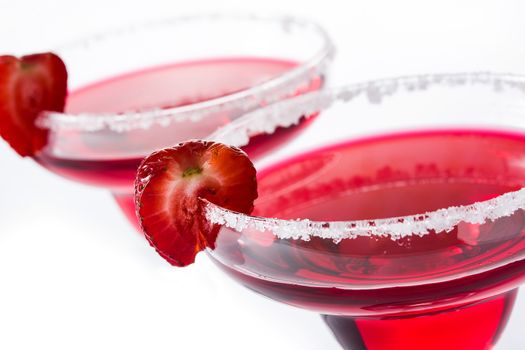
[[206, 72, 525, 350]]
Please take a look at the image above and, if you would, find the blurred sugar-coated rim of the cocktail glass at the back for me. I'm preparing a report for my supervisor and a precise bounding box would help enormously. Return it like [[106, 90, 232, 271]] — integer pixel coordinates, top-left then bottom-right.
[[36, 13, 335, 132]]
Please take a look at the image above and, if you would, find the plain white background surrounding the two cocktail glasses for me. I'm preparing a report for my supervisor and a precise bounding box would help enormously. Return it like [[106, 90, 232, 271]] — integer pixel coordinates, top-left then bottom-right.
[[0, 0, 525, 350]]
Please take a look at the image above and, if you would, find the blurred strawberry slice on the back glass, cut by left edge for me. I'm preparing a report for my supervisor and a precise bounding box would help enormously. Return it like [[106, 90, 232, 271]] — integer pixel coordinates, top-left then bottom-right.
[[0, 53, 67, 156]]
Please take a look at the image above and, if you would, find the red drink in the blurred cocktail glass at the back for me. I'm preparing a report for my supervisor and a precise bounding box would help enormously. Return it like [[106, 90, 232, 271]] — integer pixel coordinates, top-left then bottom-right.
[[36, 58, 322, 227]]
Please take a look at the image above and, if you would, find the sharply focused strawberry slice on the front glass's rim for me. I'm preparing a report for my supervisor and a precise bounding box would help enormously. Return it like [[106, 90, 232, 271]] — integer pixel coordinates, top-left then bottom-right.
[[135, 141, 257, 266]]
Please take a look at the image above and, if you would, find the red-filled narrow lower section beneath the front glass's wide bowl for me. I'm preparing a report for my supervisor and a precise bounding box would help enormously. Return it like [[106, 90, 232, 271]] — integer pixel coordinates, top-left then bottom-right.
[[322, 289, 517, 350]]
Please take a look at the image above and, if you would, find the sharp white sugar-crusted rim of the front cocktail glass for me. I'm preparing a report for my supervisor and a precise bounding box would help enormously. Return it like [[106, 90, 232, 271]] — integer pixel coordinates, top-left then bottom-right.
[[205, 72, 525, 242]]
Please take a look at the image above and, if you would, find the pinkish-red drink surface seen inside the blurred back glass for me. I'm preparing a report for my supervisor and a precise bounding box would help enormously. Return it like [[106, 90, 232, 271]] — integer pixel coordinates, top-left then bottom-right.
[[66, 57, 297, 113]]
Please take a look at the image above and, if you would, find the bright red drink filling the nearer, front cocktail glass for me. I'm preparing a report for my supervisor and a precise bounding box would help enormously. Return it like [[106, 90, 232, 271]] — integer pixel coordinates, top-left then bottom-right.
[[210, 130, 525, 350]]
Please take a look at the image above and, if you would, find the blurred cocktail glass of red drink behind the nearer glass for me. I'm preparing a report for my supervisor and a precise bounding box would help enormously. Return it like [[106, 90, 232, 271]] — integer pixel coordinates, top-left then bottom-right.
[[29, 14, 334, 230]]
